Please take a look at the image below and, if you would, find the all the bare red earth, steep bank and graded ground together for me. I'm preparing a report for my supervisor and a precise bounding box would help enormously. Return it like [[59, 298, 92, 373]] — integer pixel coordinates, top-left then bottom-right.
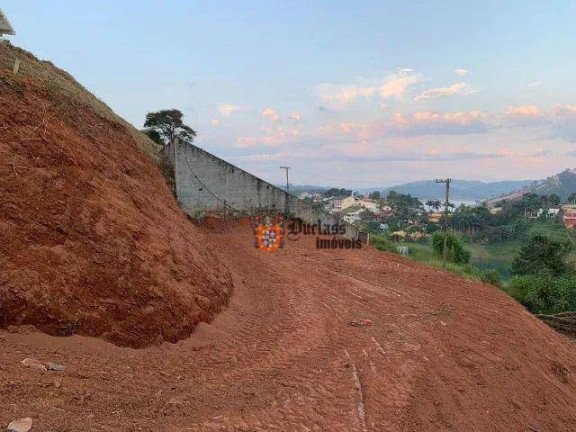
[[0, 41, 576, 432]]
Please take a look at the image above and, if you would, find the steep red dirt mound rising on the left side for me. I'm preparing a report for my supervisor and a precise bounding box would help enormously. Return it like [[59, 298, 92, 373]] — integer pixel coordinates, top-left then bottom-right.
[[0, 43, 232, 347]]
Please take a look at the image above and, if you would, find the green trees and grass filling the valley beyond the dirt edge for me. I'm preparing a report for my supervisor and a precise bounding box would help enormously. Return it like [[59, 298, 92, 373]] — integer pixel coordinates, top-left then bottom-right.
[[362, 191, 576, 314]]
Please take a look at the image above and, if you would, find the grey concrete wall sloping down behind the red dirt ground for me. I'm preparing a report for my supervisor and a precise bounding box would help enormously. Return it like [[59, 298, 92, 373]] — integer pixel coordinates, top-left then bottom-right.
[[165, 140, 358, 238]]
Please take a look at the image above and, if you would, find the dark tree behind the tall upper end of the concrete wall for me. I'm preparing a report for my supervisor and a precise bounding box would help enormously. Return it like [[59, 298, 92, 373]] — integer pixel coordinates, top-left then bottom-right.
[[144, 109, 196, 144]]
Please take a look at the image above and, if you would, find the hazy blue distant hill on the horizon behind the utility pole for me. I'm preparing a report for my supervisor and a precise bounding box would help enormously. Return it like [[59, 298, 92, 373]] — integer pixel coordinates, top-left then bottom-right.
[[380, 180, 534, 201]]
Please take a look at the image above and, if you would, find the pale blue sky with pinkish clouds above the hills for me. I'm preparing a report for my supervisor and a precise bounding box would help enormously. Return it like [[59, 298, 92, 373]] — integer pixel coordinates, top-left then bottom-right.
[[0, 0, 576, 188]]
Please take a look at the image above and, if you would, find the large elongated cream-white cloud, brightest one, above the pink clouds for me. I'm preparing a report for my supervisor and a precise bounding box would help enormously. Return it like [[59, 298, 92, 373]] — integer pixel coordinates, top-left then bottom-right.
[[316, 69, 424, 109]]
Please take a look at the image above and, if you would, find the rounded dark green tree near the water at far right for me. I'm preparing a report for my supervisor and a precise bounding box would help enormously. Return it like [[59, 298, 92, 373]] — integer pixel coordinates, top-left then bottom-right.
[[512, 234, 570, 276]]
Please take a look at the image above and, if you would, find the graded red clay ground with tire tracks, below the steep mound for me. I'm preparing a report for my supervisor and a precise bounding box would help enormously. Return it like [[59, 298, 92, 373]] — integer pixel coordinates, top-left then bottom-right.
[[0, 222, 576, 432]]
